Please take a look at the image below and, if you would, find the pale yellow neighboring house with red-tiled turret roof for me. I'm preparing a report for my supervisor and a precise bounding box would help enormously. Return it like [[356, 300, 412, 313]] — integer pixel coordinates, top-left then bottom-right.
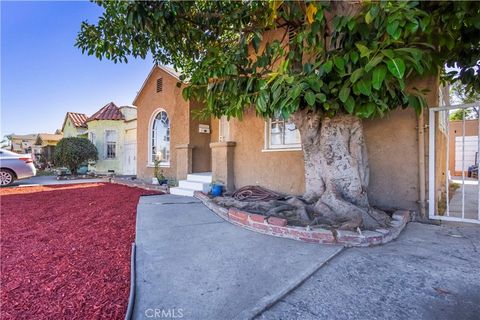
[[86, 102, 137, 175]]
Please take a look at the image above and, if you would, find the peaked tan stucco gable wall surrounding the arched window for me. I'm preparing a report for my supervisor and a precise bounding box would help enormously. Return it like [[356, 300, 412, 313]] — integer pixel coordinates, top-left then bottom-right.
[[135, 68, 189, 180]]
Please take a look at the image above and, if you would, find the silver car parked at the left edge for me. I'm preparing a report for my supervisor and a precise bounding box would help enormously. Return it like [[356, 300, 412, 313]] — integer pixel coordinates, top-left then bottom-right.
[[0, 149, 37, 187]]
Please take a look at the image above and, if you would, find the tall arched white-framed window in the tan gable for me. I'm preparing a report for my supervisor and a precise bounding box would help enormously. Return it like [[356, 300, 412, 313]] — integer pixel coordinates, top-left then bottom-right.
[[150, 110, 170, 164]]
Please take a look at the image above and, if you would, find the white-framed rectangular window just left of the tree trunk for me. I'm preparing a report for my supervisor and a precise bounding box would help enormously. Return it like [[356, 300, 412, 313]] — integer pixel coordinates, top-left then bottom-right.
[[265, 118, 302, 150]]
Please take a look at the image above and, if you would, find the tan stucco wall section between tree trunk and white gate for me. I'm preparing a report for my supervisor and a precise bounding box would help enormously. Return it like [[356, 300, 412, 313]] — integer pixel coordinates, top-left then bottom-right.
[[363, 109, 419, 210]]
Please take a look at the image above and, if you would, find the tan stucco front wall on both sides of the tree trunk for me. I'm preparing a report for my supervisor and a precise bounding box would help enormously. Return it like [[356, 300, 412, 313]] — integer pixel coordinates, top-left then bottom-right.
[[212, 110, 418, 209]]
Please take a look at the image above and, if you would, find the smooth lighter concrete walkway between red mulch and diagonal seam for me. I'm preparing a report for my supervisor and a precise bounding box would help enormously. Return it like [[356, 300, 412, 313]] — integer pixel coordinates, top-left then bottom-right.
[[133, 195, 342, 320]]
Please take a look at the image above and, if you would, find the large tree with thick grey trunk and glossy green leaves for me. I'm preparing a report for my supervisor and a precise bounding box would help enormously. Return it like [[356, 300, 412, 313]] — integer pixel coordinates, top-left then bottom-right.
[[77, 1, 480, 229]]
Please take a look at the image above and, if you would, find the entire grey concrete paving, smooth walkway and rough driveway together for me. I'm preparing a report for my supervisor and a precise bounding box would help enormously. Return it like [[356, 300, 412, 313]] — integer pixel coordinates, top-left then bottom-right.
[[134, 195, 480, 320]]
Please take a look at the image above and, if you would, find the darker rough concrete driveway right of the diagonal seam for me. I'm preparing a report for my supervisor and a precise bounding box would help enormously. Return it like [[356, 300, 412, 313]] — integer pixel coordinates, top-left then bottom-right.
[[257, 223, 480, 320]]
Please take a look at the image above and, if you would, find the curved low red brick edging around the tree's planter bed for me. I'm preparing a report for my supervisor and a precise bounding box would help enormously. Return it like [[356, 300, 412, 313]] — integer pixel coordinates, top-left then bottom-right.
[[194, 191, 410, 247]]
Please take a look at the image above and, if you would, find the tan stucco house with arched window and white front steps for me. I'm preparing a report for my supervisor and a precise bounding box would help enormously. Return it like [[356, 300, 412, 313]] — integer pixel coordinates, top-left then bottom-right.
[[133, 66, 445, 214]]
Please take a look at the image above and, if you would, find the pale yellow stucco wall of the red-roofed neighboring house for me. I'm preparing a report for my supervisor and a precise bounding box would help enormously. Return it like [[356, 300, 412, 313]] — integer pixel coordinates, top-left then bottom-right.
[[88, 120, 125, 174]]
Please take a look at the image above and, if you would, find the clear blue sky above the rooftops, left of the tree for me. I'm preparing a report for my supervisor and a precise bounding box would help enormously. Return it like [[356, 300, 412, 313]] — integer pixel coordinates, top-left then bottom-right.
[[0, 1, 153, 137]]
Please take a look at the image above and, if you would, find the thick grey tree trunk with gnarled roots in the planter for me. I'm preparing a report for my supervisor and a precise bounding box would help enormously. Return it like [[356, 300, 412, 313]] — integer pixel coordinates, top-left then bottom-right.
[[293, 110, 389, 230]]
